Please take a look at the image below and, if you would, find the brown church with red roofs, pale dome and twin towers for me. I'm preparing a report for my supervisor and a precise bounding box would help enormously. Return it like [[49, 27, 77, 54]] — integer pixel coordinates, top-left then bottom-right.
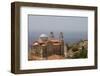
[[31, 32, 64, 59]]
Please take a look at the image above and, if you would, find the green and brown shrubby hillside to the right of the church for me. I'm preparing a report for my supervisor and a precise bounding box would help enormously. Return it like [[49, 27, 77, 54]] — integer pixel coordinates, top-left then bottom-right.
[[67, 41, 88, 59]]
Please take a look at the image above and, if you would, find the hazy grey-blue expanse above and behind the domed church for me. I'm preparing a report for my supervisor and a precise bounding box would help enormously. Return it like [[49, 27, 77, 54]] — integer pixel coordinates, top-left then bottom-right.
[[28, 15, 88, 44]]
